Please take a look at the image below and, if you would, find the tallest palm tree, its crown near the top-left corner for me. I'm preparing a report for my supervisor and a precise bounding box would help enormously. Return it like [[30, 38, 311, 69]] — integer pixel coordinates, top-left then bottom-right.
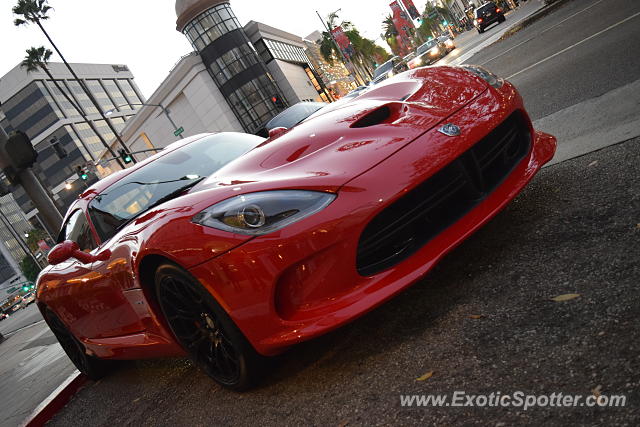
[[12, 0, 129, 169]]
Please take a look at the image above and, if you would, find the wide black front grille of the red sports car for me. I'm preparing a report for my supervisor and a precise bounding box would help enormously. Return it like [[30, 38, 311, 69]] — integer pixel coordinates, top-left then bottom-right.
[[356, 112, 531, 276]]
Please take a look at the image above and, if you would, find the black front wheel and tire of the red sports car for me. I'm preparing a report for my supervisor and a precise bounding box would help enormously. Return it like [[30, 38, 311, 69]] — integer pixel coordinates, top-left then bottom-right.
[[155, 264, 265, 391]]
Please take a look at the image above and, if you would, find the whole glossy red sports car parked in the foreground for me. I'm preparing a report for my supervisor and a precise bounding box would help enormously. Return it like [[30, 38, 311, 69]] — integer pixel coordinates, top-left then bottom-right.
[[37, 66, 556, 389]]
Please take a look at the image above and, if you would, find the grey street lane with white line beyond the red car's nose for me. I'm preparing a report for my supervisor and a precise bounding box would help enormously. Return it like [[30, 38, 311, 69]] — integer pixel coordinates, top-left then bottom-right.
[[466, 0, 640, 120]]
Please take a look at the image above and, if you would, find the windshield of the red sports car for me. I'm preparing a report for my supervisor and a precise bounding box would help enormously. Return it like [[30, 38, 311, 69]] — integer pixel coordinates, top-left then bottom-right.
[[89, 133, 264, 241]]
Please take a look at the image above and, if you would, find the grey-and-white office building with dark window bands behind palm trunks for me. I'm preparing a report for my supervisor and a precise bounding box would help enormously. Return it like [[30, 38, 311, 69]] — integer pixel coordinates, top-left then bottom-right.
[[0, 63, 144, 219]]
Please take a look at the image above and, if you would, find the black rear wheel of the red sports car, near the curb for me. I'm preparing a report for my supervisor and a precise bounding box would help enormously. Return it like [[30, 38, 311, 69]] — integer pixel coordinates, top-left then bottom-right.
[[45, 309, 110, 381]]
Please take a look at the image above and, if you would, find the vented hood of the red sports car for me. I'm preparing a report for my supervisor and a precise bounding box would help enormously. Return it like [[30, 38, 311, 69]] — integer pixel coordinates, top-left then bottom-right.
[[198, 67, 487, 189]]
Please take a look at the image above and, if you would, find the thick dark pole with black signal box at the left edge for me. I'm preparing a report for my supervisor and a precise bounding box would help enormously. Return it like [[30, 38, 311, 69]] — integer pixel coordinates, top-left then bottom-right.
[[0, 126, 62, 239]]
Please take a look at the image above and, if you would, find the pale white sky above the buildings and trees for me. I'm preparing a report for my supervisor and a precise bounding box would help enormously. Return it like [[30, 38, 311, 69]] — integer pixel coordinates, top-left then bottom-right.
[[0, 0, 426, 98]]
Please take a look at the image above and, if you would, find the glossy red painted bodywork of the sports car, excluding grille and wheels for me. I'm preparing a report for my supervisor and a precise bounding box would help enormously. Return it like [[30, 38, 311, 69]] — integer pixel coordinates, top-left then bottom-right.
[[37, 67, 556, 359]]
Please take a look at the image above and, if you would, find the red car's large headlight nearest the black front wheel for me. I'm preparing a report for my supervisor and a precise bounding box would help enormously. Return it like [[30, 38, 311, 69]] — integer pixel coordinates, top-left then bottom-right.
[[192, 190, 336, 236]]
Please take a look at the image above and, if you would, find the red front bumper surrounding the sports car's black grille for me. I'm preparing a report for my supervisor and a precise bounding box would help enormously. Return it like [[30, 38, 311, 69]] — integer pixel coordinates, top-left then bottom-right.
[[190, 83, 556, 355]]
